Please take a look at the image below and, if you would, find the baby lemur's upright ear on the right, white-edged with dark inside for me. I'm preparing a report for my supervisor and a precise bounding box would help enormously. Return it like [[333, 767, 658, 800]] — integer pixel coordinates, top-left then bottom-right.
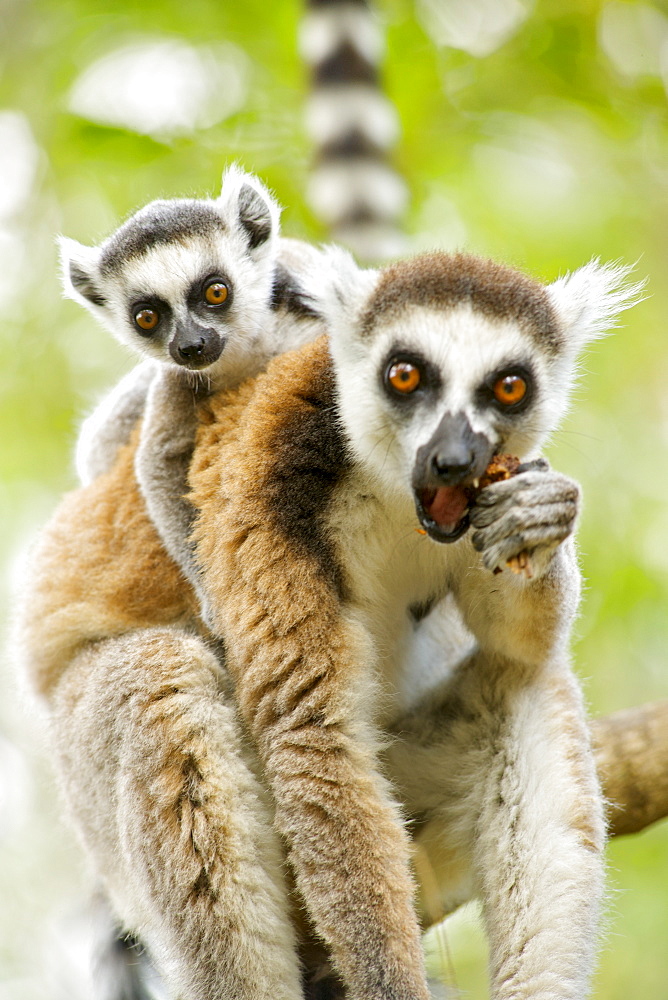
[[216, 164, 281, 258]]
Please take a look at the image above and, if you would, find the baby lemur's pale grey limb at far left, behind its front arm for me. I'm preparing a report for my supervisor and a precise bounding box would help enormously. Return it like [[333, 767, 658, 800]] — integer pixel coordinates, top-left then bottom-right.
[[75, 361, 159, 486]]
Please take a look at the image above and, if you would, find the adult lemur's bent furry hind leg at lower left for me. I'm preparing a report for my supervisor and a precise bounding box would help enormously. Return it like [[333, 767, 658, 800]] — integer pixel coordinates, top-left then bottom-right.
[[52, 629, 302, 1000]]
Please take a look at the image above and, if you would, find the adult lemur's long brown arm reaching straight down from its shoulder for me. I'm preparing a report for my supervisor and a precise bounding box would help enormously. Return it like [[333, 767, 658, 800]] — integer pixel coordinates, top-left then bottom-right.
[[185, 343, 429, 1000]]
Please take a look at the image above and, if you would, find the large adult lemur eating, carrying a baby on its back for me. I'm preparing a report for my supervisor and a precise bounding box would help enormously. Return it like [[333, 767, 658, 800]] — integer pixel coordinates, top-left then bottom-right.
[[18, 238, 633, 1000]]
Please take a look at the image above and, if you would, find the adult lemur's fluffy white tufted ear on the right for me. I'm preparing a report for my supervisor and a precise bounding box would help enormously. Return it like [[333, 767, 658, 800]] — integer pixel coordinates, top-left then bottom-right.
[[547, 260, 645, 352]]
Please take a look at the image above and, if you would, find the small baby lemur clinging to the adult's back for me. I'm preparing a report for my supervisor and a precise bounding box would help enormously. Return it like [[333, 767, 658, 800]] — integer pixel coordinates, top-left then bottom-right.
[[60, 167, 323, 596]]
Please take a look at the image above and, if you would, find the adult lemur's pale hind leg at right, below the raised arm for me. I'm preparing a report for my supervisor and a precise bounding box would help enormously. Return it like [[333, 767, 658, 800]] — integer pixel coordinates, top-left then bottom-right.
[[387, 652, 605, 1000]]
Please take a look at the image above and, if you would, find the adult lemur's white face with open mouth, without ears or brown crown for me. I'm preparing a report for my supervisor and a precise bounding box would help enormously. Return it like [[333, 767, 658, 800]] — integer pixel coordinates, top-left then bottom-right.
[[376, 304, 550, 542]]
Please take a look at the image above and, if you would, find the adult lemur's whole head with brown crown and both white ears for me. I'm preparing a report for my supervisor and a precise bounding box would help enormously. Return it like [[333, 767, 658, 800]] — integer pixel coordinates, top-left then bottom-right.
[[328, 254, 637, 542]]
